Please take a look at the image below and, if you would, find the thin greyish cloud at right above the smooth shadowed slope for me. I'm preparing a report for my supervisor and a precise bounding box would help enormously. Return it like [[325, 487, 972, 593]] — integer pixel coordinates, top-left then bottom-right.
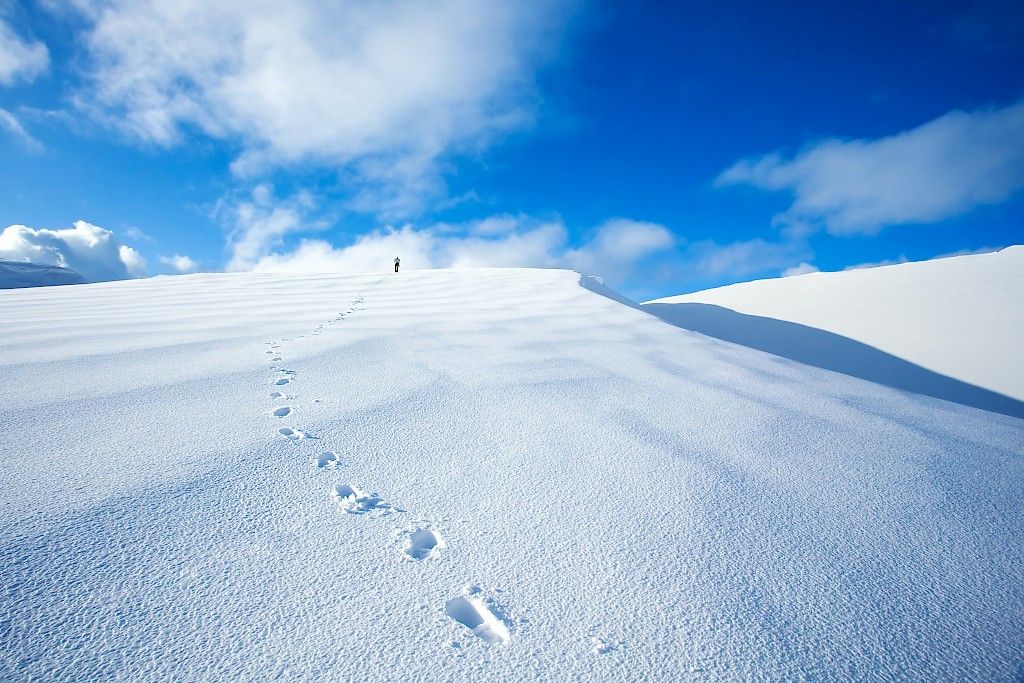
[[716, 103, 1024, 234]]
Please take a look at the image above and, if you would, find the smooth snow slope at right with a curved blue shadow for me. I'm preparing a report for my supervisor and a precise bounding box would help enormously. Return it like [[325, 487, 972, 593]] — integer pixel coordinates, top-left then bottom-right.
[[644, 246, 1024, 417]]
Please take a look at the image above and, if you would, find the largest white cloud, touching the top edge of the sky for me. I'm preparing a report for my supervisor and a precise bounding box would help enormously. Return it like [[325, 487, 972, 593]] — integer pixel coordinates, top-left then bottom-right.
[[66, 0, 569, 216]]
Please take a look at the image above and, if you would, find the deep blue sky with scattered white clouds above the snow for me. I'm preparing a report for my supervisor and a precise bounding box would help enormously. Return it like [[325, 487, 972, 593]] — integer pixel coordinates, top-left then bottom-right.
[[0, 0, 1024, 298]]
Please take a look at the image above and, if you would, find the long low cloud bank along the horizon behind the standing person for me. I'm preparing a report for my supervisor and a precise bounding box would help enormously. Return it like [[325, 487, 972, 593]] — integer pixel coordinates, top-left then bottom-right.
[[241, 214, 813, 288]]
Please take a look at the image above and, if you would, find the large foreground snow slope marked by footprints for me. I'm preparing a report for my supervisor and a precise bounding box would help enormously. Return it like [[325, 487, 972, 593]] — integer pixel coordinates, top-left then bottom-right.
[[0, 269, 1024, 681]]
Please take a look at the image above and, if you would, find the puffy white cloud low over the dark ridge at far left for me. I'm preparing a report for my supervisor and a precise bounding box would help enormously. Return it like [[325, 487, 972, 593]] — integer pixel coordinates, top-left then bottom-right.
[[0, 220, 145, 282]]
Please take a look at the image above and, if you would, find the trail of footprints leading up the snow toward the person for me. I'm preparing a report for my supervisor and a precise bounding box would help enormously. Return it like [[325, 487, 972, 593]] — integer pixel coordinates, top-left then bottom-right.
[[260, 281, 511, 648]]
